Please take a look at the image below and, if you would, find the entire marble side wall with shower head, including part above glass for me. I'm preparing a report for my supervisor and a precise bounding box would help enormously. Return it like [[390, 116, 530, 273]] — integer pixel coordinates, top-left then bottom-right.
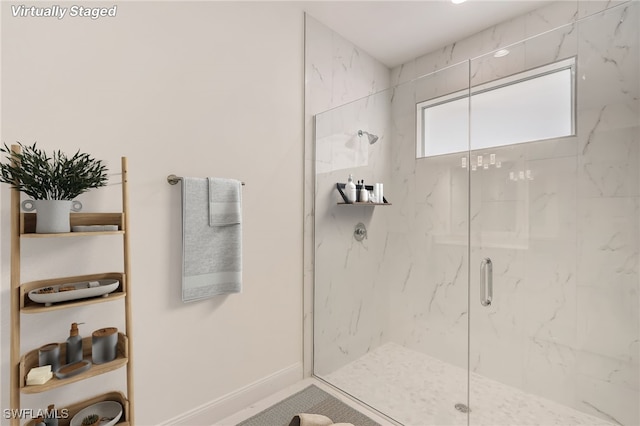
[[304, 15, 390, 375]]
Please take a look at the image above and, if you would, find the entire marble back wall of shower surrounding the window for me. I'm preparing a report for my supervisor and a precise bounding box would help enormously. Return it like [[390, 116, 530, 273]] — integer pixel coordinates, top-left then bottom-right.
[[387, 2, 640, 425]]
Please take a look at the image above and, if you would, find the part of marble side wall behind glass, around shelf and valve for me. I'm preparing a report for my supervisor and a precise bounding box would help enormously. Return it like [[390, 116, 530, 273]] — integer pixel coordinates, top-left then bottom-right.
[[314, 91, 395, 376]]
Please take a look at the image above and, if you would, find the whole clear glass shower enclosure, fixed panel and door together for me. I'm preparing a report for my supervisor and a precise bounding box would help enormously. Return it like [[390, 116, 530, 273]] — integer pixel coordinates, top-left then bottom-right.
[[314, 2, 640, 425]]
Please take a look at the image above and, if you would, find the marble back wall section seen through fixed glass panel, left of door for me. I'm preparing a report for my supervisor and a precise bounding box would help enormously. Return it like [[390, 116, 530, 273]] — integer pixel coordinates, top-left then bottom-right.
[[387, 62, 469, 368]]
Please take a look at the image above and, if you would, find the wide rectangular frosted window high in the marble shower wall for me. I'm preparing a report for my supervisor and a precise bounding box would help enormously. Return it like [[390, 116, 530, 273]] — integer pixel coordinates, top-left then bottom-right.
[[417, 58, 575, 157]]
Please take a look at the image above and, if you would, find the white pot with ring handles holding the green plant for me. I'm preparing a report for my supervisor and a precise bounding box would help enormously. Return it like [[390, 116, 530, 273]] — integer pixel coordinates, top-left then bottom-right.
[[22, 200, 82, 234]]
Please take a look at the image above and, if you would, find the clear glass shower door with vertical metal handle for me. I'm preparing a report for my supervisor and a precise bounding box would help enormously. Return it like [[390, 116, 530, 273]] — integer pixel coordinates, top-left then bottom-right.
[[469, 3, 640, 425]]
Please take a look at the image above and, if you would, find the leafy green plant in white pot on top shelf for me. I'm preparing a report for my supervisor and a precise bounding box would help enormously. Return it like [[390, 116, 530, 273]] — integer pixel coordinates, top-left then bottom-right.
[[0, 143, 107, 233]]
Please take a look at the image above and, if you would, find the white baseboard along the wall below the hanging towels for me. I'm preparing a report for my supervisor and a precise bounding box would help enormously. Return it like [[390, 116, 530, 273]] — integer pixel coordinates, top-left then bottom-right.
[[160, 363, 303, 426]]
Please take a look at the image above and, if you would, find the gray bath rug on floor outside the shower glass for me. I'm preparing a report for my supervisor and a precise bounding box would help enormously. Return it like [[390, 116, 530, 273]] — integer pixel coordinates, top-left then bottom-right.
[[237, 385, 380, 426]]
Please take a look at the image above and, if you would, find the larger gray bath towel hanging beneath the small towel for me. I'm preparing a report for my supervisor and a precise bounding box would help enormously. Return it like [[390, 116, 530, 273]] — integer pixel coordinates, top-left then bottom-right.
[[182, 177, 242, 302]]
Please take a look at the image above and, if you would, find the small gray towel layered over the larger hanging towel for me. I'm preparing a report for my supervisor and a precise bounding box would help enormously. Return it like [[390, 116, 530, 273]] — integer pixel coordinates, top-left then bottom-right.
[[207, 177, 242, 226]]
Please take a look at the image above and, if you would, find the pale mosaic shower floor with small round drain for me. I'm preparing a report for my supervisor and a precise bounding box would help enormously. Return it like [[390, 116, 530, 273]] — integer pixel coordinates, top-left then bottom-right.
[[322, 343, 613, 426]]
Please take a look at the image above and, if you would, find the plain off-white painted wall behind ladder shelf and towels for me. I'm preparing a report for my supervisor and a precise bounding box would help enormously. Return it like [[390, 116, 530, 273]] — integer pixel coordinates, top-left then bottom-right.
[[1, 2, 304, 425]]
